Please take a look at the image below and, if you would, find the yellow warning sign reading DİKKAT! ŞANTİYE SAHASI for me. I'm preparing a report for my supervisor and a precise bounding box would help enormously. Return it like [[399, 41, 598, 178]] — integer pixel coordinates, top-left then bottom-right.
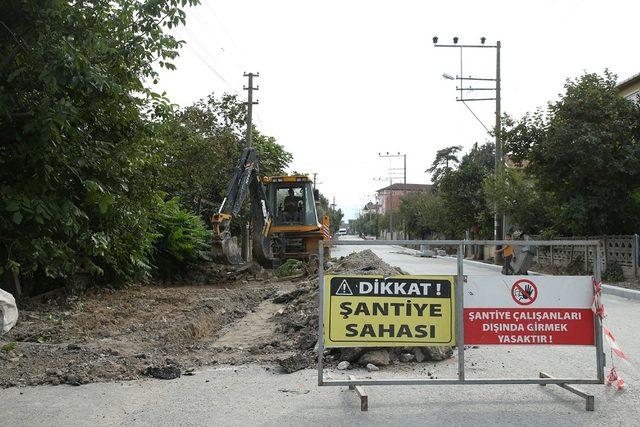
[[324, 276, 455, 347]]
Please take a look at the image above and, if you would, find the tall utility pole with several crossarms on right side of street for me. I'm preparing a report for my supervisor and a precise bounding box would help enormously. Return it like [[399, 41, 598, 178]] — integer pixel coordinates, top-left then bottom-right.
[[433, 36, 505, 264]]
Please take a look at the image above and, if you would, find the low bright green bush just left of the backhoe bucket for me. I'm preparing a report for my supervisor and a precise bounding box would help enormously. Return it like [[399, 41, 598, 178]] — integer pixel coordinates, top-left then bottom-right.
[[152, 196, 211, 277]]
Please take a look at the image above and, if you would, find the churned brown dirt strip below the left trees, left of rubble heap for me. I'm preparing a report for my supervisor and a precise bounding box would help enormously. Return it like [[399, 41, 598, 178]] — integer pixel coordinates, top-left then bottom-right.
[[0, 265, 284, 388]]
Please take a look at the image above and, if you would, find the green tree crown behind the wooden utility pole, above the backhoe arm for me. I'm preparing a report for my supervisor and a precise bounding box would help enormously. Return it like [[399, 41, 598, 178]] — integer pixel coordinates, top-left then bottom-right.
[[154, 94, 292, 219]]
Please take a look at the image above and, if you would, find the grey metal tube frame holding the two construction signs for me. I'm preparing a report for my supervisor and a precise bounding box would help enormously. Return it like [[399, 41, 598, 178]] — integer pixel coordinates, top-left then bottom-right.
[[317, 240, 605, 411]]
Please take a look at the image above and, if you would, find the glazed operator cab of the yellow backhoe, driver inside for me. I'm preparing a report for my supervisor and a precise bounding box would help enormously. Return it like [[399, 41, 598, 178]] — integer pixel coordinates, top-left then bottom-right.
[[264, 176, 318, 228]]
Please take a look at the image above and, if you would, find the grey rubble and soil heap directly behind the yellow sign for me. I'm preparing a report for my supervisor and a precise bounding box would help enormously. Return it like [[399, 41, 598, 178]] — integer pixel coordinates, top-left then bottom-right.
[[272, 250, 453, 372]]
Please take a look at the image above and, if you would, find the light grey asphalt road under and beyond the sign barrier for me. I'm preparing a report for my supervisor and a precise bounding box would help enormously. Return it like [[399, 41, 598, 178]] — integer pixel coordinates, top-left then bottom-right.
[[0, 239, 640, 425]]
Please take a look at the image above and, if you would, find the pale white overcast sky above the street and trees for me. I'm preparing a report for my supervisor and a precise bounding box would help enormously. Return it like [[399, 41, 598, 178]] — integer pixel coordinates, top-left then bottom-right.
[[157, 0, 640, 219]]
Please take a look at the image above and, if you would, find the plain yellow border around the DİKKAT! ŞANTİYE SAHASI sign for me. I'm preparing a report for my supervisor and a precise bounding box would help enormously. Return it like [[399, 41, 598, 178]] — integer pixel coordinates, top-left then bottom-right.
[[322, 274, 456, 348]]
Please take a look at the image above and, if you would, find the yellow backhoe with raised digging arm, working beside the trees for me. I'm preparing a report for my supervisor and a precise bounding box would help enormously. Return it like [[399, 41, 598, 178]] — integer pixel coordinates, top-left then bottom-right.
[[211, 147, 330, 268]]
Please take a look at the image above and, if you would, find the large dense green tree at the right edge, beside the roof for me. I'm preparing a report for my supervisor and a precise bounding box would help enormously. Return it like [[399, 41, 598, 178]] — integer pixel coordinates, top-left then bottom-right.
[[504, 71, 640, 235]]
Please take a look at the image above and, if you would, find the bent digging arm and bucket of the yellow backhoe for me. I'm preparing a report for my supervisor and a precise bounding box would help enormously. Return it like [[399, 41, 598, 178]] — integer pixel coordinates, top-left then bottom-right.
[[211, 147, 273, 267]]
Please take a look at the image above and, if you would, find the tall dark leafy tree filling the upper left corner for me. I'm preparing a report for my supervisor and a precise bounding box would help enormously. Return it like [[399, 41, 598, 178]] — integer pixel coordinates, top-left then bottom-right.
[[0, 0, 198, 290]]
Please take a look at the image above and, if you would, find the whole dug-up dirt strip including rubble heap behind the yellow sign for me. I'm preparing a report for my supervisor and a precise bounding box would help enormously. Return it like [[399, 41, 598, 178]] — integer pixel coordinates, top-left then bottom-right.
[[0, 250, 450, 387]]
